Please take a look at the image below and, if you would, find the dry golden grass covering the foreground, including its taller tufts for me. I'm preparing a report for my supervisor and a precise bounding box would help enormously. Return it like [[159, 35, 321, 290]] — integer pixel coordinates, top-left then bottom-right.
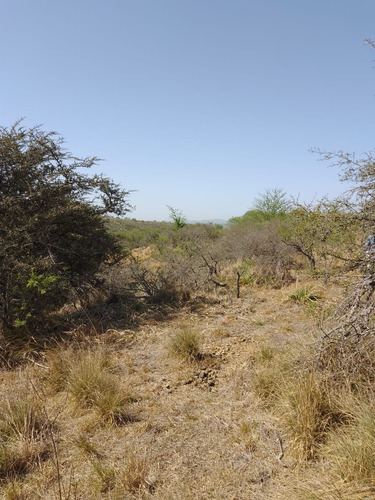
[[0, 283, 375, 500]]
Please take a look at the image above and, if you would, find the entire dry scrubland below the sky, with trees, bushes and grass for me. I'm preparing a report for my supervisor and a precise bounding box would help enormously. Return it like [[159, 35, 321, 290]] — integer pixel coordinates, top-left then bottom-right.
[[0, 119, 375, 500]]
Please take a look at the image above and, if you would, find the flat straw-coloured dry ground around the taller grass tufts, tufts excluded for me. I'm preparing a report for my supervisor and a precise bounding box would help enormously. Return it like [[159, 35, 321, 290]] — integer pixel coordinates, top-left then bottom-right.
[[0, 284, 375, 500]]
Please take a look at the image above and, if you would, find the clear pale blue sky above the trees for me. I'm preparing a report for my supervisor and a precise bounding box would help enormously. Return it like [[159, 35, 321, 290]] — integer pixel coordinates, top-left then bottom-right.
[[0, 0, 375, 220]]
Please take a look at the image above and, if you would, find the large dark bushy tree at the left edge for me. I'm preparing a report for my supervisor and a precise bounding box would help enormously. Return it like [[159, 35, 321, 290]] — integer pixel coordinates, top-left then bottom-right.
[[0, 122, 131, 334]]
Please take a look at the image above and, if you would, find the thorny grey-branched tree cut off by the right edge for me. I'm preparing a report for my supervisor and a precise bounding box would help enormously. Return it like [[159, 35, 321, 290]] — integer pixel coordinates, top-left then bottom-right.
[[316, 40, 375, 374]]
